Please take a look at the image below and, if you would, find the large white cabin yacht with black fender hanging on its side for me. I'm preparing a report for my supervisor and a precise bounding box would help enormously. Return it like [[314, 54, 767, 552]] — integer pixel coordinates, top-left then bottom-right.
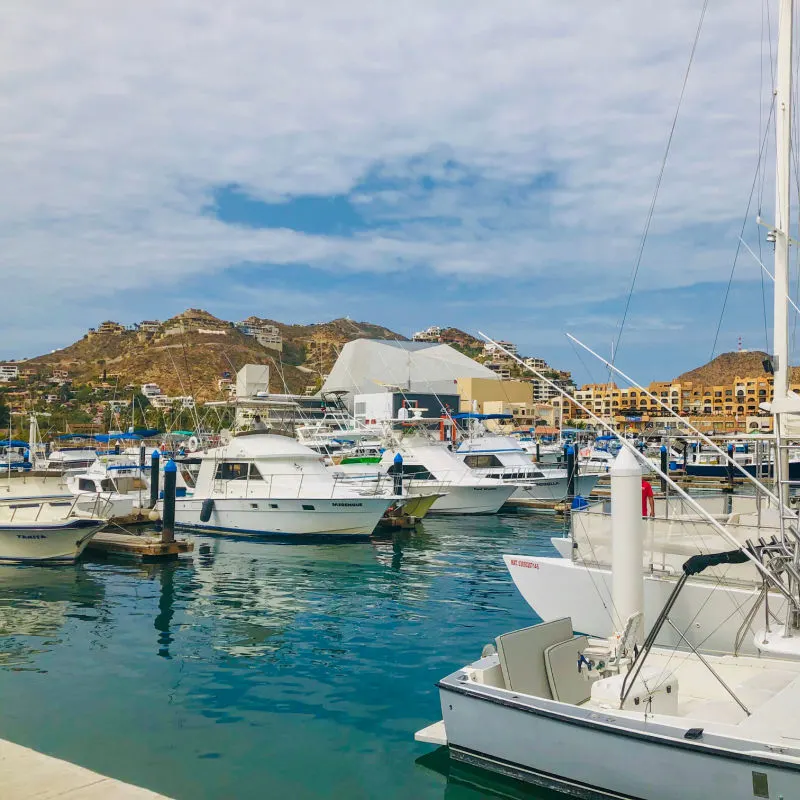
[[168, 432, 396, 539]]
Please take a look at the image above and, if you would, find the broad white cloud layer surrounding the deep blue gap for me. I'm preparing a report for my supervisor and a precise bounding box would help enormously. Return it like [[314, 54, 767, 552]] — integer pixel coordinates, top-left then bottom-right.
[[0, 0, 780, 350]]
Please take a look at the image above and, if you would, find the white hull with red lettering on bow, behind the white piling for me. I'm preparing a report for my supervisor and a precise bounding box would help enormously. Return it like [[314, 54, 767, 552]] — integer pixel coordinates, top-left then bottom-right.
[[503, 555, 772, 655]]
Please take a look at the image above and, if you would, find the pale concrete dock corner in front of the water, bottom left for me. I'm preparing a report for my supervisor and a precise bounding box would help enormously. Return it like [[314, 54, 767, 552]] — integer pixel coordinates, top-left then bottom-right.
[[0, 739, 168, 800]]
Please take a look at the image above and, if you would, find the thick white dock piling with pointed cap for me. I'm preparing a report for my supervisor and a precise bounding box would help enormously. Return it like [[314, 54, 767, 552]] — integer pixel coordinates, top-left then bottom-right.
[[610, 447, 644, 633]]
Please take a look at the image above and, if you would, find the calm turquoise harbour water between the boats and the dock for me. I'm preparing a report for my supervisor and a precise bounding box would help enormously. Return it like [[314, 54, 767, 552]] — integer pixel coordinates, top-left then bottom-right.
[[0, 513, 562, 800]]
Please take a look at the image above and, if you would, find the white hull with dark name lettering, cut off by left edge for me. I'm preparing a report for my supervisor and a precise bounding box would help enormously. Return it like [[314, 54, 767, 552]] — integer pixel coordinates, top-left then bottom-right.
[[0, 519, 105, 564]]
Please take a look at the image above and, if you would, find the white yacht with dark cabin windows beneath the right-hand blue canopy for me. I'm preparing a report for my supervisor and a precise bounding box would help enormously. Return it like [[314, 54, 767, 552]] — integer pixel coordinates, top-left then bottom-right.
[[457, 434, 599, 501]]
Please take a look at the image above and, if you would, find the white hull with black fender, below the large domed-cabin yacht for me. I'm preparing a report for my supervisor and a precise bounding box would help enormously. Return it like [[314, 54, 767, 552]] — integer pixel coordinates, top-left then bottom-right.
[[175, 497, 392, 538]]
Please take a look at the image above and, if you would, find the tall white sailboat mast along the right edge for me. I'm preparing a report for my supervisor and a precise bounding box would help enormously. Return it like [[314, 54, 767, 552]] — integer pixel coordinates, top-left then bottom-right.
[[772, 0, 794, 502]]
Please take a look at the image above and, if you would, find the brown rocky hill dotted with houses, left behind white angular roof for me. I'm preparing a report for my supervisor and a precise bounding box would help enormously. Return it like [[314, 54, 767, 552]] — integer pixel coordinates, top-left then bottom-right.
[[20, 309, 404, 401]]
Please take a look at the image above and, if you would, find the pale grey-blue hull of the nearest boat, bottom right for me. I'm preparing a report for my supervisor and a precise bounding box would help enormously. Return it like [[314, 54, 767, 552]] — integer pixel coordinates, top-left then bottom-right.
[[439, 673, 800, 800]]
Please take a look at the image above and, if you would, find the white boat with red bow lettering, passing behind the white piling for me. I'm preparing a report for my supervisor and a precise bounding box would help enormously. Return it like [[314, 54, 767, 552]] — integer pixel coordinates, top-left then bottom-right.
[[503, 495, 785, 653]]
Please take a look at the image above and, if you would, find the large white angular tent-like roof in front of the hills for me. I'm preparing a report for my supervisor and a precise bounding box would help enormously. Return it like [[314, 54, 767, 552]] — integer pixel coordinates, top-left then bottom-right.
[[321, 339, 499, 401]]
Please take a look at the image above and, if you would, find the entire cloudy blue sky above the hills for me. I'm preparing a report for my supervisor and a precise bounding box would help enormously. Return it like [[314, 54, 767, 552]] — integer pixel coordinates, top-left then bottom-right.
[[0, 0, 796, 382]]
